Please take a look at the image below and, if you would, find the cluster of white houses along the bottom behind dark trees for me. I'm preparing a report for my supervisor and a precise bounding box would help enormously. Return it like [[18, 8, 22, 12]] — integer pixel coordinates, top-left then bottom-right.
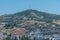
[[0, 30, 60, 40]]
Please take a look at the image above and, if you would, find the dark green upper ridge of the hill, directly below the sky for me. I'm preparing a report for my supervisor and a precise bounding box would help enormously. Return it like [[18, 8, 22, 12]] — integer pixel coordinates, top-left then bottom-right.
[[0, 9, 60, 22]]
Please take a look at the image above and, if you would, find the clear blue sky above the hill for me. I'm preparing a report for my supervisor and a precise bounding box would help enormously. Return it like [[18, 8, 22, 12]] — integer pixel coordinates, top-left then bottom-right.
[[0, 0, 60, 15]]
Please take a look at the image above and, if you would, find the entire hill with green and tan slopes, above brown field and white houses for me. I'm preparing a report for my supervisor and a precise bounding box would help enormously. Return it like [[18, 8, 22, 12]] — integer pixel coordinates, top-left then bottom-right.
[[0, 9, 60, 34]]
